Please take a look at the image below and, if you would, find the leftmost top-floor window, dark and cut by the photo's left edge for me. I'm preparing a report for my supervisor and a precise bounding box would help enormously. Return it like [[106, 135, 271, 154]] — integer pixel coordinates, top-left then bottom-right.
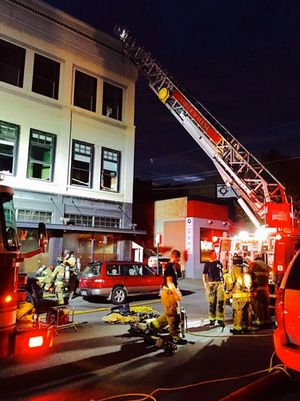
[[0, 39, 25, 88]]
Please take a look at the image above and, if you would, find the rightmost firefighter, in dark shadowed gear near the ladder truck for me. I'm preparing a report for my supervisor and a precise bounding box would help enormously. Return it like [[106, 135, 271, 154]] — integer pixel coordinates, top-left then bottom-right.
[[250, 254, 273, 329]]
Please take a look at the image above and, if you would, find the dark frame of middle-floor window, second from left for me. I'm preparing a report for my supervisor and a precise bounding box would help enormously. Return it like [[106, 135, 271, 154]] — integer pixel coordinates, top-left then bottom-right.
[[26, 128, 56, 182]]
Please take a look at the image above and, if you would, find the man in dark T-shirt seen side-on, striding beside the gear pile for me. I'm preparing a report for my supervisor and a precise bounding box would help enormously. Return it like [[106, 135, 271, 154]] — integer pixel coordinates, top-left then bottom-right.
[[151, 249, 187, 344]]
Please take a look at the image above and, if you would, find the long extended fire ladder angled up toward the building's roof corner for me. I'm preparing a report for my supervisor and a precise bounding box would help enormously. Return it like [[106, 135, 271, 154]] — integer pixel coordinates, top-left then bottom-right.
[[116, 27, 290, 226]]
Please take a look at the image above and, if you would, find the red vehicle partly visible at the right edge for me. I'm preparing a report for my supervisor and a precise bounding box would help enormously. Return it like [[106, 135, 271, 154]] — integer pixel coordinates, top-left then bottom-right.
[[274, 251, 300, 372]]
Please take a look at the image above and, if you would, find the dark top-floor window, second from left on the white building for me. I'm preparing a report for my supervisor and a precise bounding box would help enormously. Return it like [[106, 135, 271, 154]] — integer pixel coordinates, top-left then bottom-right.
[[31, 53, 61, 100]]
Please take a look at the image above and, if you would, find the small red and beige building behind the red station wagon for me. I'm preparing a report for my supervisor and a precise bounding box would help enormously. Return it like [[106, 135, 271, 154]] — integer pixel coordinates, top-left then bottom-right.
[[154, 197, 233, 279]]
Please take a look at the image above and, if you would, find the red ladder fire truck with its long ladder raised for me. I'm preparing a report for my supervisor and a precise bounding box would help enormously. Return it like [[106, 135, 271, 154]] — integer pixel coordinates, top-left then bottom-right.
[[115, 27, 300, 284]]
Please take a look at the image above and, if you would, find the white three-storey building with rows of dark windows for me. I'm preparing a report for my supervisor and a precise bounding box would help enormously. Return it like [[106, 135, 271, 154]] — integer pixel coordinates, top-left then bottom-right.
[[0, 0, 142, 263]]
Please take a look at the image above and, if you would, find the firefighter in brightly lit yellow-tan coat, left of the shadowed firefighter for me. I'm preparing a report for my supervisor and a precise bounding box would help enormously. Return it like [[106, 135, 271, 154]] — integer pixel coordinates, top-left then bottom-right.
[[224, 255, 252, 334]]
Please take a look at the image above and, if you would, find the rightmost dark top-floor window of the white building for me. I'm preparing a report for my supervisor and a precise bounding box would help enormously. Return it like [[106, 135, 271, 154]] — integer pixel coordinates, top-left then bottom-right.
[[102, 82, 123, 120]]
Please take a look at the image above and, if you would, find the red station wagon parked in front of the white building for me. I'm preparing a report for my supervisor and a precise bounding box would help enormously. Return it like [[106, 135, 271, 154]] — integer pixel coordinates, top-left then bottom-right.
[[77, 261, 163, 305]]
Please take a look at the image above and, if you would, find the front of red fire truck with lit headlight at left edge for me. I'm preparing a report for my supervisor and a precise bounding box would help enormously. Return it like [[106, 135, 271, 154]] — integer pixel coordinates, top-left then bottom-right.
[[0, 180, 54, 359]]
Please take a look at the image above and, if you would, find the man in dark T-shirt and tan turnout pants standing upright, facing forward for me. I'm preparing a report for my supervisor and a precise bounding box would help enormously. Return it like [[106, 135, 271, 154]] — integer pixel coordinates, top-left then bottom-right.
[[202, 250, 225, 327]]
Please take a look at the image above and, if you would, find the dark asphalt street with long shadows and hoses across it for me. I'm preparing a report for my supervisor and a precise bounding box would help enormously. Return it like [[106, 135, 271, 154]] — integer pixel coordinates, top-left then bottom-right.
[[0, 279, 300, 401]]
